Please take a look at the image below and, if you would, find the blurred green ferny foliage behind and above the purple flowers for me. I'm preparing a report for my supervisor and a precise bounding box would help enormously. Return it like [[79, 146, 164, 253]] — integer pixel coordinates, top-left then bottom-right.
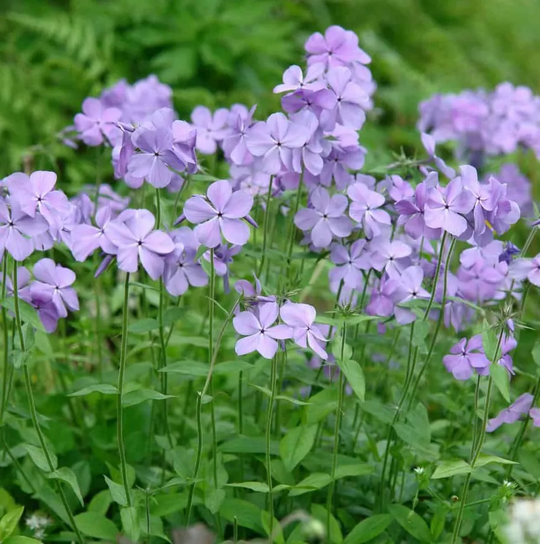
[[0, 0, 540, 178]]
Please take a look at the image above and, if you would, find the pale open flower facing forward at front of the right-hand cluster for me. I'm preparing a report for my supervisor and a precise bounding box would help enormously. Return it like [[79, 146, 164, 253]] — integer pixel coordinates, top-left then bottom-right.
[[424, 178, 475, 236]]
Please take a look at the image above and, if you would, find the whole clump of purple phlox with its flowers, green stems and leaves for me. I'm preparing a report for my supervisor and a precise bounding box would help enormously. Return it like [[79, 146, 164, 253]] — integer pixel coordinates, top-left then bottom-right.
[[0, 26, 540, 544]]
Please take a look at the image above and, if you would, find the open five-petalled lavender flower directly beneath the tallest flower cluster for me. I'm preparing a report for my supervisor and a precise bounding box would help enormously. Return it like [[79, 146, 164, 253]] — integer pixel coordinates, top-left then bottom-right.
[[294, 187, 352, 248]]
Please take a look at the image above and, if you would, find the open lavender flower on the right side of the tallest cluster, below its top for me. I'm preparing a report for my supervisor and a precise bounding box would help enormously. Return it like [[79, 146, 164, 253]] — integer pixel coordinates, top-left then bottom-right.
[[321, 66, 369, 130]]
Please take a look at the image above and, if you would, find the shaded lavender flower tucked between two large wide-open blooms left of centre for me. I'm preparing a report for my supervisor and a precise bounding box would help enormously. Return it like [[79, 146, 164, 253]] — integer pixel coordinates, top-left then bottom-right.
[[163, 227, 208, 296]]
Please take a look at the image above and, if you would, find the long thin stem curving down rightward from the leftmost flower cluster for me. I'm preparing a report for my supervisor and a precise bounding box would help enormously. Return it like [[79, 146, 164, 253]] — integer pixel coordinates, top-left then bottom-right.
[[13, 261, 84, 544]]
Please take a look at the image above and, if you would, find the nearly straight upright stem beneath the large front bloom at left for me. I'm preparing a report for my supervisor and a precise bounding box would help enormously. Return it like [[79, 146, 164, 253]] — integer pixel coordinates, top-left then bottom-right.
[[116, 272, 132, 507]]
